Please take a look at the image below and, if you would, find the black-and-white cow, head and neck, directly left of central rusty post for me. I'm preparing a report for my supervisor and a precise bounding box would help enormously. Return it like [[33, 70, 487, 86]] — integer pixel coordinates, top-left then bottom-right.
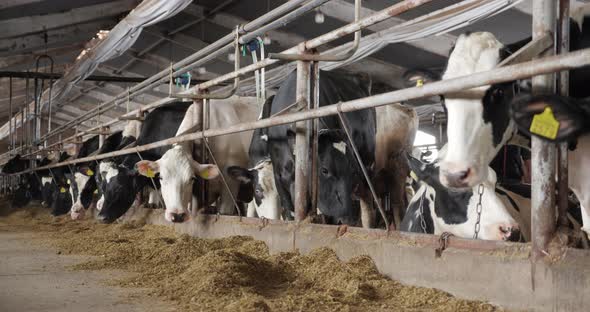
[[227, 96, 282, 220]]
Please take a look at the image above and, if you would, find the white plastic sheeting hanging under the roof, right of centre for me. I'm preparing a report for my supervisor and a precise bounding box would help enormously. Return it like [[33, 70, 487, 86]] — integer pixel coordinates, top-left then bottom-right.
[[239, 0, 523, 95]]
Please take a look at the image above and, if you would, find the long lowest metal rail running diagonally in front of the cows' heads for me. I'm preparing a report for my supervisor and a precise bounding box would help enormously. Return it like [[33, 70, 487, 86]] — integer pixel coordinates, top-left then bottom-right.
[[10, 49, 590, 174]]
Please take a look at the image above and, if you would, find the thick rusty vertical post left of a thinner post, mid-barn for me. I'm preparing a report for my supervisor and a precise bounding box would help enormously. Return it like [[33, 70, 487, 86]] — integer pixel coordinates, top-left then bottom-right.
[[294, 48, 310, 222]]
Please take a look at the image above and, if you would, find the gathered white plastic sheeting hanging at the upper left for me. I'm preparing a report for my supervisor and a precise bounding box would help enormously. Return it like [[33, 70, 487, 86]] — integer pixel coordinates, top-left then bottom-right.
[[0, 0, 192, 138]]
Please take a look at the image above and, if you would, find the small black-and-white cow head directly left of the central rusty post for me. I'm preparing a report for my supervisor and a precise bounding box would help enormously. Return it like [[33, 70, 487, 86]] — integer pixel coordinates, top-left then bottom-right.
[[227, 159, 281, 220]]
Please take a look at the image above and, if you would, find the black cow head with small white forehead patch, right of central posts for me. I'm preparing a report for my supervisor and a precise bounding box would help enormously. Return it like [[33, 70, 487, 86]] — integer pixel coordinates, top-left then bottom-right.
[[318, 130, 364, 224]]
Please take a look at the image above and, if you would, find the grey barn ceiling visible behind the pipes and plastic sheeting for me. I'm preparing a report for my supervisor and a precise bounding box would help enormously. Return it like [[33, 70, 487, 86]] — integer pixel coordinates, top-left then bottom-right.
[[0, 0, 568, 149]]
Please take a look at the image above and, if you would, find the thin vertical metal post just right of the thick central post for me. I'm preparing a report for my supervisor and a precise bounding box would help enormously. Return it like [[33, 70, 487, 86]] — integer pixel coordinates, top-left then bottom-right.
[[308, 62, 320, 213]]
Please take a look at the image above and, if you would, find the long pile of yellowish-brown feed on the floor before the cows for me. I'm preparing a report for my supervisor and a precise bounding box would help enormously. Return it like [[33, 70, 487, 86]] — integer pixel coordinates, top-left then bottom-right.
[[0, 203, 498, 311]]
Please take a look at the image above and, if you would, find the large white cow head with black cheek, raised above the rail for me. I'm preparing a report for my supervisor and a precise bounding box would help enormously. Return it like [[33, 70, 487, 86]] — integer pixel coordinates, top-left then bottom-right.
[[440, 32, 515, 188]]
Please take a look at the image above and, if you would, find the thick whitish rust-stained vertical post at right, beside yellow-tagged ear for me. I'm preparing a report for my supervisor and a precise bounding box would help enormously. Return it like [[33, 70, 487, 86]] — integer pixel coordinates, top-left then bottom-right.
[[531, 0, 557, 259]]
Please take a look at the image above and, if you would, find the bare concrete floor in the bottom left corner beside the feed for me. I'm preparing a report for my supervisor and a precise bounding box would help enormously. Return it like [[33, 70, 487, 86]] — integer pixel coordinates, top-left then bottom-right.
[[0, 230, 175, 312]]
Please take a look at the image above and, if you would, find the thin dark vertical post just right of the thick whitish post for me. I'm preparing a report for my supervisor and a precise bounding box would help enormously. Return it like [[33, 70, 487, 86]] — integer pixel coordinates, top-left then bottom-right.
[[557, 0, 570, 227]]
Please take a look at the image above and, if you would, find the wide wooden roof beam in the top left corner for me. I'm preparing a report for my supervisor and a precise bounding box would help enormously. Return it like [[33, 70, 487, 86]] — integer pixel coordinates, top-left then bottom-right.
[[0, 0, 139, 38]]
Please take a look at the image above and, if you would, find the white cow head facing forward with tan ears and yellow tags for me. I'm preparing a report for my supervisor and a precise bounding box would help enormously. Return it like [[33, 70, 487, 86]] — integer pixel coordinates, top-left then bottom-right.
[[136, 145, 219, 222]]
